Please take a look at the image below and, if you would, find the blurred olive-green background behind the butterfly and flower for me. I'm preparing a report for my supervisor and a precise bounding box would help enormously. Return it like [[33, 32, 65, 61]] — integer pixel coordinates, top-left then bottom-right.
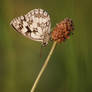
[[0, 0, 92, 92]]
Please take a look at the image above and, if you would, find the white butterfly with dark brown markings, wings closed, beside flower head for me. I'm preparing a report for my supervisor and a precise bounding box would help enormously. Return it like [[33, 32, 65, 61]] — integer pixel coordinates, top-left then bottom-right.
[[10, 9, 51, 46]]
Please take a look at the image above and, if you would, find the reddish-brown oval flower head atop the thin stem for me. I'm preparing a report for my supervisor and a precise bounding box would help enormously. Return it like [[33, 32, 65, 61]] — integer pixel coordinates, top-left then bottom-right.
[[51, 18, 74, 43]]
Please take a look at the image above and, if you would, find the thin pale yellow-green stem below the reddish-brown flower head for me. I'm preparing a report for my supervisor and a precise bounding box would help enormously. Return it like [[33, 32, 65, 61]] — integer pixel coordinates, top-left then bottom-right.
[[30, 42, 57, 92]]
